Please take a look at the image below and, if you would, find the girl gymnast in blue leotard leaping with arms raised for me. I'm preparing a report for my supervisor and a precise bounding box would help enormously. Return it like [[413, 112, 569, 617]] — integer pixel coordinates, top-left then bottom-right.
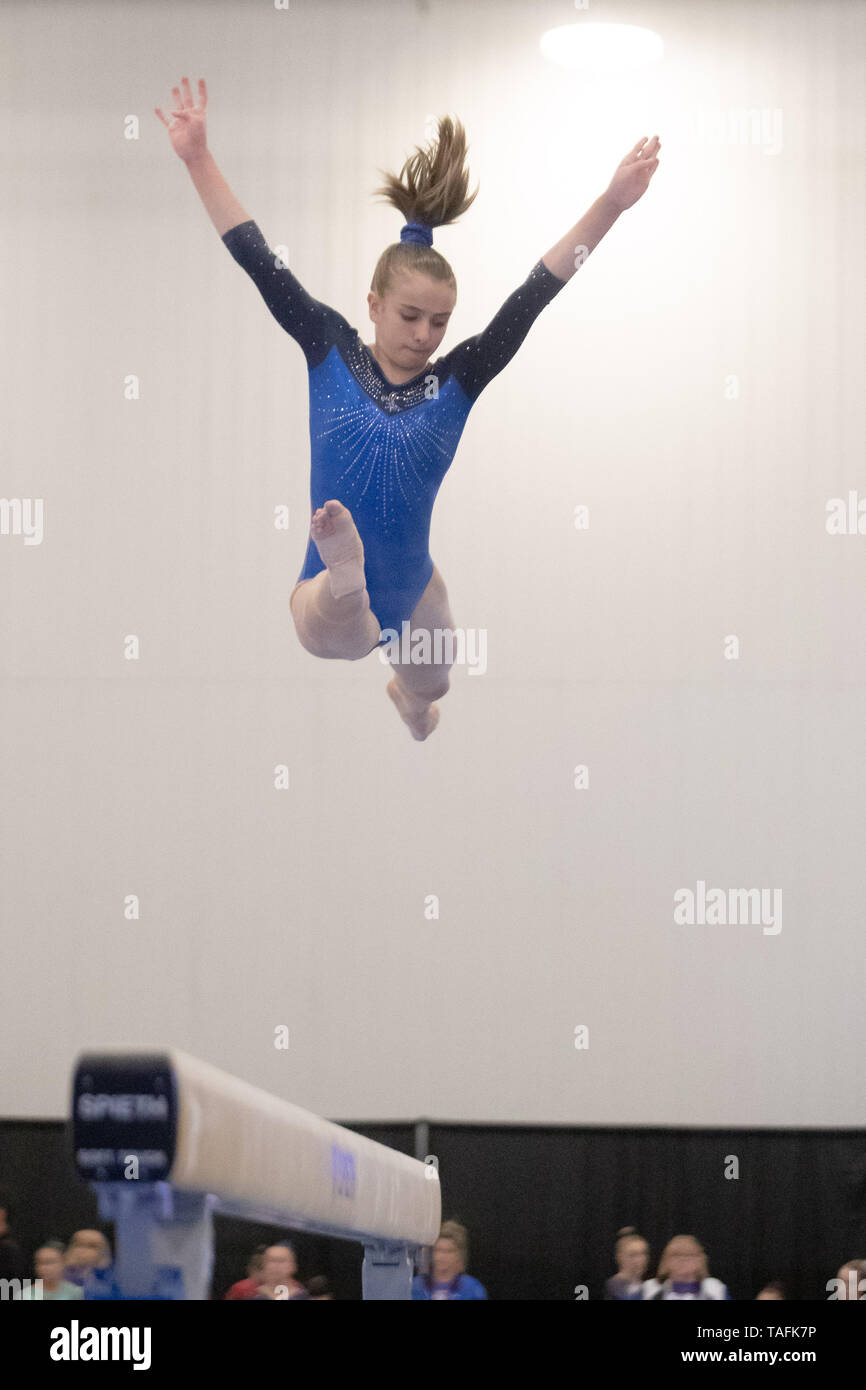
[[154, 78, 660, 739]]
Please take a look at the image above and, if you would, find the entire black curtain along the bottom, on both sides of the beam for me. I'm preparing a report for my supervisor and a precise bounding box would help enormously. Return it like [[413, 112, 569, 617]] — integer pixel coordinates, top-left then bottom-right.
[[0, 1120, 866, 1300]]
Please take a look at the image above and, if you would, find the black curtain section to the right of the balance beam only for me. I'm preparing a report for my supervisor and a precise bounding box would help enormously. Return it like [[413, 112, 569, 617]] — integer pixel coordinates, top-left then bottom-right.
[[430, 1125, 866, 1300]]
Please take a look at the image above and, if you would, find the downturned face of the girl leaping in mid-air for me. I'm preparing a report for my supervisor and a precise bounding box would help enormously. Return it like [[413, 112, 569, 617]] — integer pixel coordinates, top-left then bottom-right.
[[367, 271, 457, 373]]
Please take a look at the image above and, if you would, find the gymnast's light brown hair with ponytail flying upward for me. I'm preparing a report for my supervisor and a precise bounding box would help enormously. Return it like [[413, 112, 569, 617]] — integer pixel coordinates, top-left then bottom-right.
[[370, 115, 478, 297]]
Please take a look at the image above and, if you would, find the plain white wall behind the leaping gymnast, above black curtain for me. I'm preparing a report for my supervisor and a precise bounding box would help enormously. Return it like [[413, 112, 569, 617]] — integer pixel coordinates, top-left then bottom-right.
[[0, 0, 866, 1126]]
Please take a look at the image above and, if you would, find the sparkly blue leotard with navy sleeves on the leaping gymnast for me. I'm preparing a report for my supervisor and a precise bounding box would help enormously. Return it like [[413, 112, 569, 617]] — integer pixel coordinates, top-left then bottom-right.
[[222, 220, 566, 646]]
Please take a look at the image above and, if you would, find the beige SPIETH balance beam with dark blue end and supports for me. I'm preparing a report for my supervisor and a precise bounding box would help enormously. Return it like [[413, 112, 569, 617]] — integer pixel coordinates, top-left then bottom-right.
[[72, 1048, 442, 1300]]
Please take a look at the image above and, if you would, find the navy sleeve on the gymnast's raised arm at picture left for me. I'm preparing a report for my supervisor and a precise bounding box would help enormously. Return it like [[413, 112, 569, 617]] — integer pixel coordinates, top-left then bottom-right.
[[222, 218, 352, 367]]
